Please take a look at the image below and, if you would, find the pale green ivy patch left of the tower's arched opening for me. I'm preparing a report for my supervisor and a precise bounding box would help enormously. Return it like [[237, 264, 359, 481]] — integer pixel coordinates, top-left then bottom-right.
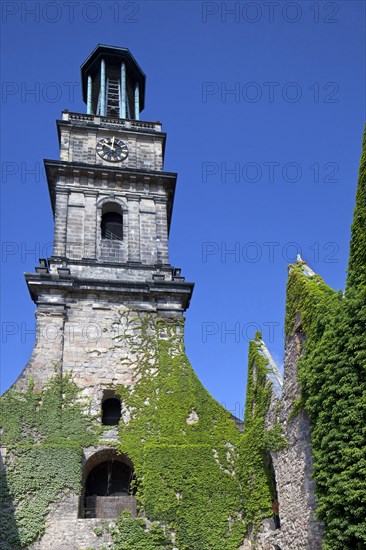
[[0, 374, 99, 550]]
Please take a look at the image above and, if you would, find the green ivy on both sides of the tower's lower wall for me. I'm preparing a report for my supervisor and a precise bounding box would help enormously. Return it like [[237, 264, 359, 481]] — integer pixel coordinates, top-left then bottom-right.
[[1, 316, 245, 550]]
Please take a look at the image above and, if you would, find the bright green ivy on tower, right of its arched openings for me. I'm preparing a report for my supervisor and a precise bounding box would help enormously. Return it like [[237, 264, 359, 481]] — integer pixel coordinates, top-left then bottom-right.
[[113, 316, 244, 550]]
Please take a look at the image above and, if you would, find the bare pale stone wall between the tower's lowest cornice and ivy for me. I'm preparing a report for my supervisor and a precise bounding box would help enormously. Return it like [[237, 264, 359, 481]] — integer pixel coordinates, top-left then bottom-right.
[[16, 302, 162, 414]]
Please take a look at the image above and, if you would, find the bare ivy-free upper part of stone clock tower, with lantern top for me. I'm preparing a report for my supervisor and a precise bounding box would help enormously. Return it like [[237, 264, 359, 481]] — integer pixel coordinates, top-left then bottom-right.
[[17, 45, 193, 396]]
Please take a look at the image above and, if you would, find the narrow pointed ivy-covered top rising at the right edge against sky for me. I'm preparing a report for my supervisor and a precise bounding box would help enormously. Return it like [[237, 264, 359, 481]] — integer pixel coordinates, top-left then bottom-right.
[[346, 125, 366, 291]]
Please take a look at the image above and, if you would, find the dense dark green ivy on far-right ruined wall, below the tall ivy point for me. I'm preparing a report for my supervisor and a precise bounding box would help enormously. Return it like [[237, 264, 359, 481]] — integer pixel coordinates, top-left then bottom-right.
[[287, 266, 366, 550]]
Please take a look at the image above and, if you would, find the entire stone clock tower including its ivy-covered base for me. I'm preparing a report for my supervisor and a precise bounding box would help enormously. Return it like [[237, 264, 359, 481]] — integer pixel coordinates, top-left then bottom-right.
[[0, 45, 244, 550]]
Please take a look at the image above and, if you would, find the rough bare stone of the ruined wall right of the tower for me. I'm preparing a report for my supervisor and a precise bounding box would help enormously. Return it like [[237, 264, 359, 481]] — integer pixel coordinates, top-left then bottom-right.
[[252, 327, 322, 550]]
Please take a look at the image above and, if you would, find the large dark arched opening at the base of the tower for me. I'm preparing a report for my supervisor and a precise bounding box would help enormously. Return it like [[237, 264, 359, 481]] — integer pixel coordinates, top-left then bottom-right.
[[80, 449, 136, 519]]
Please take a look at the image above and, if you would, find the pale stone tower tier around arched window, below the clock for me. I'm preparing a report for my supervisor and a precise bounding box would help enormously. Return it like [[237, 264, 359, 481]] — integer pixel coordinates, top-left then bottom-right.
[[54, 176, 169, 279]]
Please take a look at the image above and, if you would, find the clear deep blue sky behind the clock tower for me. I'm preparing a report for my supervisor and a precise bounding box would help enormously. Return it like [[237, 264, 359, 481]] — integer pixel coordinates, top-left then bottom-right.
[[1, 0, 365, 416]]
